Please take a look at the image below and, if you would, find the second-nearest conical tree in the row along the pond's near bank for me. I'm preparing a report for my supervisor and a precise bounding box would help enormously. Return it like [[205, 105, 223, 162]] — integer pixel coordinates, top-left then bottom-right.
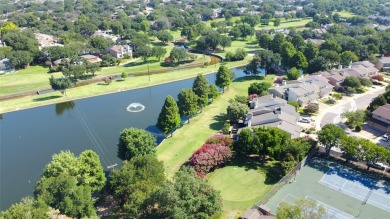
[[177, 89, 198, 123]]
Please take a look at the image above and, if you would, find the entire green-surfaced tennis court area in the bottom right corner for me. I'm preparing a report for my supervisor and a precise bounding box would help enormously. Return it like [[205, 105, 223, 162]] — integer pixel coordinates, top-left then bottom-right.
[[264, 157, 390, 219]]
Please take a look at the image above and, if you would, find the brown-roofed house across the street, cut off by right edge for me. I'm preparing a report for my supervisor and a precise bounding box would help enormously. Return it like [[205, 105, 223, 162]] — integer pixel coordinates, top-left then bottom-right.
[[368, 104, 390, 133]]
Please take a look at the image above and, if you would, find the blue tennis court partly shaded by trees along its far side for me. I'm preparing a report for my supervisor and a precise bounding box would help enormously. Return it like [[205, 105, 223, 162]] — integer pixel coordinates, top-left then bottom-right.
[[319, 166, 390, 212]]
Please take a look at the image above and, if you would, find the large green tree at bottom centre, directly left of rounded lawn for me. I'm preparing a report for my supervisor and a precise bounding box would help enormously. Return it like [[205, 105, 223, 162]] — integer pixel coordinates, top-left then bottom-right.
[[145, 167, 222, 219]]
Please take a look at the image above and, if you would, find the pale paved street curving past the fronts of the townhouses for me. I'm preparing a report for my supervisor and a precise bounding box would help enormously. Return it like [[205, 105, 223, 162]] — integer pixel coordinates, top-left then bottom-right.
[[316, 87, 385, 130]]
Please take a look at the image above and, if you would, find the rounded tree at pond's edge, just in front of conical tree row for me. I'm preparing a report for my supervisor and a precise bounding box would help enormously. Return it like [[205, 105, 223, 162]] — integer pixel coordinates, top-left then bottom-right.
[[118, 128, 157, 160]]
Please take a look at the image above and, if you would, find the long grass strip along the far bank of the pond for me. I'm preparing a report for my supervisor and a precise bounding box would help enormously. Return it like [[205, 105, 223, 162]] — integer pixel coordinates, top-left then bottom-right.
[[0, 57, 250, 113]]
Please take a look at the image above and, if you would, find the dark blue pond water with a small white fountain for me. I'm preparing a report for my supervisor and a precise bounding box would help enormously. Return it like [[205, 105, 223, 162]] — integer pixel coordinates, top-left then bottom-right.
[[0, 68, 248, 210]]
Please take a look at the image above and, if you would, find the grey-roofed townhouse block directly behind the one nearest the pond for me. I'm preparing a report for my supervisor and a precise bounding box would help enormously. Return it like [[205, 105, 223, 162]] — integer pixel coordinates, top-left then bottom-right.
[[268, 75, 333, 106]]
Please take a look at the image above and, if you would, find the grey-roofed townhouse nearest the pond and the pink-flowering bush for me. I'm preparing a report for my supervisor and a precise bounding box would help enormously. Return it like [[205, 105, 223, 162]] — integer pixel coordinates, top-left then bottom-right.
[[244, 94, 302, 138]]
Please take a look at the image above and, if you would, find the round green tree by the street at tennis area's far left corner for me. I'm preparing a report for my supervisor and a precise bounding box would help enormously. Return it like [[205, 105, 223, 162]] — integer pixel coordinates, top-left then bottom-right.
[[318, 124, 345, 156]]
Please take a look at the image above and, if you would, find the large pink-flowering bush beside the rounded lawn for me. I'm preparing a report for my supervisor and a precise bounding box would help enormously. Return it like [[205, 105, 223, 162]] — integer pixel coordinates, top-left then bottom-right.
[[189, 143, 232, 178]]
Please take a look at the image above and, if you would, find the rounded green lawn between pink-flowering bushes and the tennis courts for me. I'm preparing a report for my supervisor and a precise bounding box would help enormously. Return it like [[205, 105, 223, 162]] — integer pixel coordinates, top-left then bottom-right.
[[207, 158, 283, 219]]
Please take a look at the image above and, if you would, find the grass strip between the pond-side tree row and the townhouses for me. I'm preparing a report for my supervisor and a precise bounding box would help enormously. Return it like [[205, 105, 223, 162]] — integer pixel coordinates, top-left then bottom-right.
[[157, 75, 274, 177]]
